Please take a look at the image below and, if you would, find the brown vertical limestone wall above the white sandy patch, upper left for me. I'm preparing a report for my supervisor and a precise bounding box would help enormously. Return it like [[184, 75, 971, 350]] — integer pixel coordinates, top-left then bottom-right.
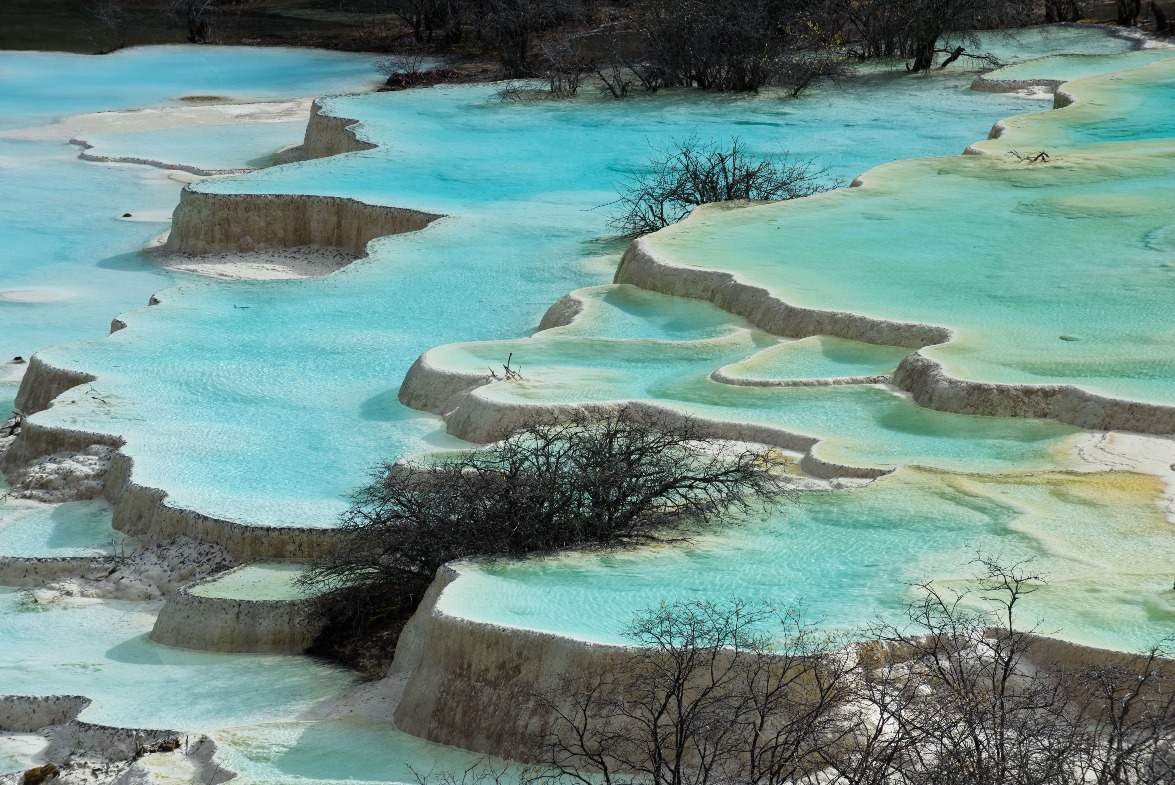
[[165, 186, 441, 256]]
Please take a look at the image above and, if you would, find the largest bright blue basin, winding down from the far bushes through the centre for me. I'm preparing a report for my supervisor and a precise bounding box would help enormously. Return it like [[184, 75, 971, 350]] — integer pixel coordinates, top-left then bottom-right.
[[25, 28, 1128, 526]]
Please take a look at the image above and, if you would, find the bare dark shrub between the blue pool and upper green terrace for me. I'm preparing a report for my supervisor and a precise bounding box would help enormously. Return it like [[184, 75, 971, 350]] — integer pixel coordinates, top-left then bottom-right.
[[612, 137, 838, 236]]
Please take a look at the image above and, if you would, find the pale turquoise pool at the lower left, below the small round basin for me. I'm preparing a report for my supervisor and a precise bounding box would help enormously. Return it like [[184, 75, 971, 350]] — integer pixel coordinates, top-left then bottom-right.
[[0, 589, 353, 731]]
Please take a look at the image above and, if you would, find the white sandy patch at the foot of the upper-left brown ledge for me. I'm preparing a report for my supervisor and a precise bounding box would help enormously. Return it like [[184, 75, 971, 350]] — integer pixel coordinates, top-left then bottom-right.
[[148, 248, 355, 281]]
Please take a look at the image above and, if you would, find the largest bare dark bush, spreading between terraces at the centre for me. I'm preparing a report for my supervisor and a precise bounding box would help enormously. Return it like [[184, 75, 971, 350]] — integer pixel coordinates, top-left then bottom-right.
[[303, 408, 784, 672]]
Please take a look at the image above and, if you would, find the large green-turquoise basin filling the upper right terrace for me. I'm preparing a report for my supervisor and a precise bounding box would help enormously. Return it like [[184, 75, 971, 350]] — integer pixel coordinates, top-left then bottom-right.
[[639, 59, 1175, 404]]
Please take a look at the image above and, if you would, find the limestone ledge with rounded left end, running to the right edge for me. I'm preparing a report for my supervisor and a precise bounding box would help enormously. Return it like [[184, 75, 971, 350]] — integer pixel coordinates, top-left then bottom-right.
[[893, 351, 1175, 435]]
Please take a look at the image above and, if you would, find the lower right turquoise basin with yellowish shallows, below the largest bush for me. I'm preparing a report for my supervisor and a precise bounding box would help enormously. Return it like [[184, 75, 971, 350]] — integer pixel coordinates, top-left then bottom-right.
[[438, 469, 1175, 650]]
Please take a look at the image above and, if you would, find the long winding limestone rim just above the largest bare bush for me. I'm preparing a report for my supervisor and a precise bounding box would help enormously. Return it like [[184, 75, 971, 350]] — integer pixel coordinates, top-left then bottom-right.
[[400, 351, 893, 479]]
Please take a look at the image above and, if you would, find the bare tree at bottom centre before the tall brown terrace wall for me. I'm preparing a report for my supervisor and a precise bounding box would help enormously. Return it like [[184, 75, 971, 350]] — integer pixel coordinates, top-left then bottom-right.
[[546, 601, 851, 785]]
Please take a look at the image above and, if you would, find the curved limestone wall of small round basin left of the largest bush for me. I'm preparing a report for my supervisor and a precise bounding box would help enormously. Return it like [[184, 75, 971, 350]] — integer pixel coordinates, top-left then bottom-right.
[[150, 566, 322, 653]]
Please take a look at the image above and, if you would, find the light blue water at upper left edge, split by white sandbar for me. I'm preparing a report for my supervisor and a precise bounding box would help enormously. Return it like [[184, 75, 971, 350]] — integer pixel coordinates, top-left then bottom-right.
[[0, 46, 376, 415]]
